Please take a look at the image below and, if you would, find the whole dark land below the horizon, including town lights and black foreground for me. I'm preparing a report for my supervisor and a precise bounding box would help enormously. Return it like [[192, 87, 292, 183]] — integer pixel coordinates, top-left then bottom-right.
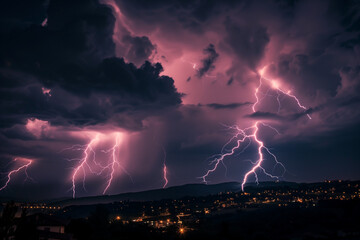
[[0, 181, 360, 240]]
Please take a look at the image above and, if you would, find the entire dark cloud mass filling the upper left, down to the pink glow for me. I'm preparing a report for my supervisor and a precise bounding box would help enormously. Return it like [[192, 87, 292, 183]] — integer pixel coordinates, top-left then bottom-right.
[[0, 0, 181, 131]]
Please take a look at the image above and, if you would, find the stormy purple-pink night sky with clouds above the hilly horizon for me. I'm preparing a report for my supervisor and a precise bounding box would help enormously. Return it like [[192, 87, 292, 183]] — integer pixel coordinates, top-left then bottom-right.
[[0, 0, 360, 199]]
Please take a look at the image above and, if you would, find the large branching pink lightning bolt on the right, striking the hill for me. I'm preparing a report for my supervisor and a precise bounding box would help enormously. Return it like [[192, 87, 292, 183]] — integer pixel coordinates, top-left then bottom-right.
[[201, 64, 311, 191]]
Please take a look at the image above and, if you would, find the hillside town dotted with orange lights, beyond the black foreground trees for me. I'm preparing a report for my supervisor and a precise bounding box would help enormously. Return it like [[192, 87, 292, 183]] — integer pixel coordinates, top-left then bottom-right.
[[2, 180, 360, 239]]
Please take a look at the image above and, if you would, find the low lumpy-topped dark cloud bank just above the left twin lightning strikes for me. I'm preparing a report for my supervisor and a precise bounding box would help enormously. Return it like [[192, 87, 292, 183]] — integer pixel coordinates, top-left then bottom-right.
[[0, 58, 181, 130]]
